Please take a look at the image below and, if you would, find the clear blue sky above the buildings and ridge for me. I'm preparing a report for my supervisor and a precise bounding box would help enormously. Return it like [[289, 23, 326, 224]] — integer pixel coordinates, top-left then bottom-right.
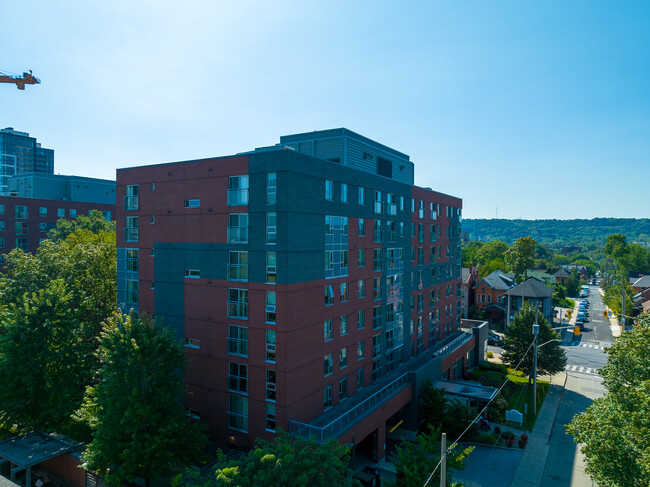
[[0, 0, 650, 218]]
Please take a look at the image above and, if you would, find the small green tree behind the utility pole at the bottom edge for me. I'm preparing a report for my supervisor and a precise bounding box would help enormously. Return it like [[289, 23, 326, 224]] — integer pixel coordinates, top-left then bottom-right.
[[389, 429, 474, 487]]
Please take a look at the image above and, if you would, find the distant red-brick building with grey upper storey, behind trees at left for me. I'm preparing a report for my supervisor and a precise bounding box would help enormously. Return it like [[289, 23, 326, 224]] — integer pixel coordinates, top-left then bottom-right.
[[0, 173, 115, 264]]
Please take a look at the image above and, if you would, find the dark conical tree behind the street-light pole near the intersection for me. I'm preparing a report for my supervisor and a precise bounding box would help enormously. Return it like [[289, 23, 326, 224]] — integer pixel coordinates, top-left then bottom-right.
[[501, 302, 566, 379]]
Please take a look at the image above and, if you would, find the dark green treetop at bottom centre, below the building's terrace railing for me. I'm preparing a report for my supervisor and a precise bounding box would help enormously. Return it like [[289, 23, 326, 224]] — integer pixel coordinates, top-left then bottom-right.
[[172, 430, 354, 487]]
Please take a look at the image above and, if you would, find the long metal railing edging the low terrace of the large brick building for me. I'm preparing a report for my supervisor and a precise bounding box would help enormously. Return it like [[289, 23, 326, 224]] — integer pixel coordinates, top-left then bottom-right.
[[289, 372, 409, 442]]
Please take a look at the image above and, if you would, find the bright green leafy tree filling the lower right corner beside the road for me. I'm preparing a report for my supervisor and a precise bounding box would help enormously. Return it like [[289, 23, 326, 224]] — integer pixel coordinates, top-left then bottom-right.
[[566, 315, 650, 487]]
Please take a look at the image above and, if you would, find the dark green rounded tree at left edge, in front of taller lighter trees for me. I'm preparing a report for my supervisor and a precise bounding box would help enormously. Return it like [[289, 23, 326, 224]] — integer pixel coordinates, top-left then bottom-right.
[[0, 279, 93, 433]]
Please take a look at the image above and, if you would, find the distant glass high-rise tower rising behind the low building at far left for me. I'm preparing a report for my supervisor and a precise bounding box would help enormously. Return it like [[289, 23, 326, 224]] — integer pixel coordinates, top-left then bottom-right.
[[0, 127, 54, 194]]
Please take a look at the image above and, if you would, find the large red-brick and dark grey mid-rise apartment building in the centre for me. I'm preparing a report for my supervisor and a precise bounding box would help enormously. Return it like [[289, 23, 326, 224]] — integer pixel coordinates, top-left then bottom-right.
[[116, 129, 480, 458]]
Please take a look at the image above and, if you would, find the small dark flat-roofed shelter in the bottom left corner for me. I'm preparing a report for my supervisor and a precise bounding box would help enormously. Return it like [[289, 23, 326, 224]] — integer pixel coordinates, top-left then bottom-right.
[[0, 431, 83, 487]]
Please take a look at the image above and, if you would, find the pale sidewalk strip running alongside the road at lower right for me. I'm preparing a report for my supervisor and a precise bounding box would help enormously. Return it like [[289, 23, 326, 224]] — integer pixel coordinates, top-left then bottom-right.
[[512, 373, 566, 487]]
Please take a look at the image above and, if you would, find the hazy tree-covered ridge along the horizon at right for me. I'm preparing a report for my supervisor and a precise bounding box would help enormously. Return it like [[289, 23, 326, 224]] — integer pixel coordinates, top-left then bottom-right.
[[463, 218, 650, 245]]
